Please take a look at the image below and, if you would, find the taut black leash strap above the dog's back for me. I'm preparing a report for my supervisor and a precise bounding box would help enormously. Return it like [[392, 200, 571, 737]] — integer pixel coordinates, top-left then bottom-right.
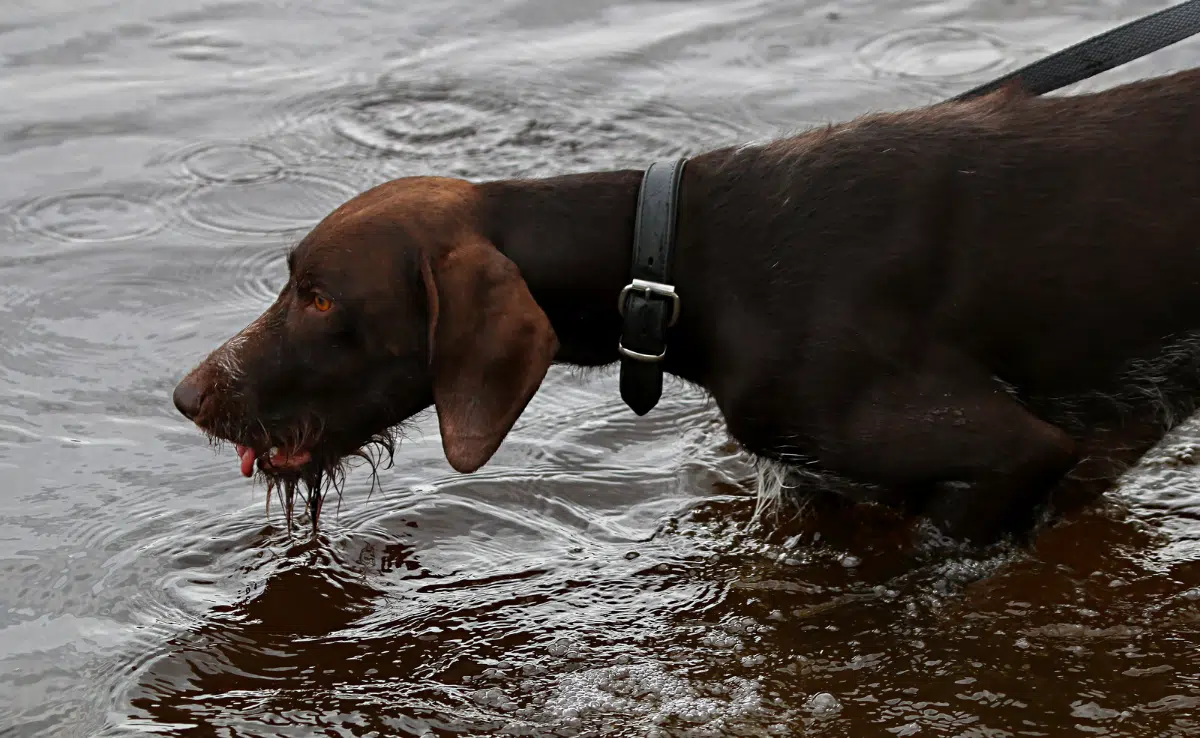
[[950, 0, 1200, 102]]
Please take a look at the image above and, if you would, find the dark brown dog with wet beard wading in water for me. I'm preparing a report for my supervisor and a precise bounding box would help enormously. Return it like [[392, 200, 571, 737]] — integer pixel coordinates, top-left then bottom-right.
[[174, 71, 1200, 540]]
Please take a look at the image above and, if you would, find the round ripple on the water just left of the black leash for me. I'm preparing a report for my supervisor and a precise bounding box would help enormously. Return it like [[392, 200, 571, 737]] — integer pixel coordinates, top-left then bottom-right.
[[858, 26, 1008, 79]]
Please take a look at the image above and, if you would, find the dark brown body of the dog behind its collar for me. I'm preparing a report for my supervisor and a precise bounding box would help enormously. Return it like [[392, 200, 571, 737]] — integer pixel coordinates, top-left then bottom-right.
[[680, 71, 1200, 537]]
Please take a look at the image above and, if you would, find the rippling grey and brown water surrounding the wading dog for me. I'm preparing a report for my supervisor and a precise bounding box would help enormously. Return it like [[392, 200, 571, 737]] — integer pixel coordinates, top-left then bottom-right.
[[0, 0, 1200, 737]]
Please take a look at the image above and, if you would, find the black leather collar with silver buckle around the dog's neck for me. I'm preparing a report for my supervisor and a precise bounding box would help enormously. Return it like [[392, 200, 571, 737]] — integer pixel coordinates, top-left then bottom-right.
[[617, 158, 688, 415]]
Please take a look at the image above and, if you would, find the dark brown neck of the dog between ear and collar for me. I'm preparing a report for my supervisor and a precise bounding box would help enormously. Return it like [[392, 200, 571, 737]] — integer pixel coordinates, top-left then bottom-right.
[[480, 170, 691, 366]]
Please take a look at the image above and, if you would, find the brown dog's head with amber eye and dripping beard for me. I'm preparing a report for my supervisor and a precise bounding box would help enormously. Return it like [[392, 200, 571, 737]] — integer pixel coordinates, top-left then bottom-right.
[[174, 178, 558, 481]]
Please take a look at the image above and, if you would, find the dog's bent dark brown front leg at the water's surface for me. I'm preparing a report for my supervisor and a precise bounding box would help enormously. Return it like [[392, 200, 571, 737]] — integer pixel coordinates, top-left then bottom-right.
[[827, 356, 1078, 544]]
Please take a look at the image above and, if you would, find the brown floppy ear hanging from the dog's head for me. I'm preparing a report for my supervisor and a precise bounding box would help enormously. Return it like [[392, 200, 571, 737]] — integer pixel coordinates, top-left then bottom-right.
[[421, 236, 558, 474]]
